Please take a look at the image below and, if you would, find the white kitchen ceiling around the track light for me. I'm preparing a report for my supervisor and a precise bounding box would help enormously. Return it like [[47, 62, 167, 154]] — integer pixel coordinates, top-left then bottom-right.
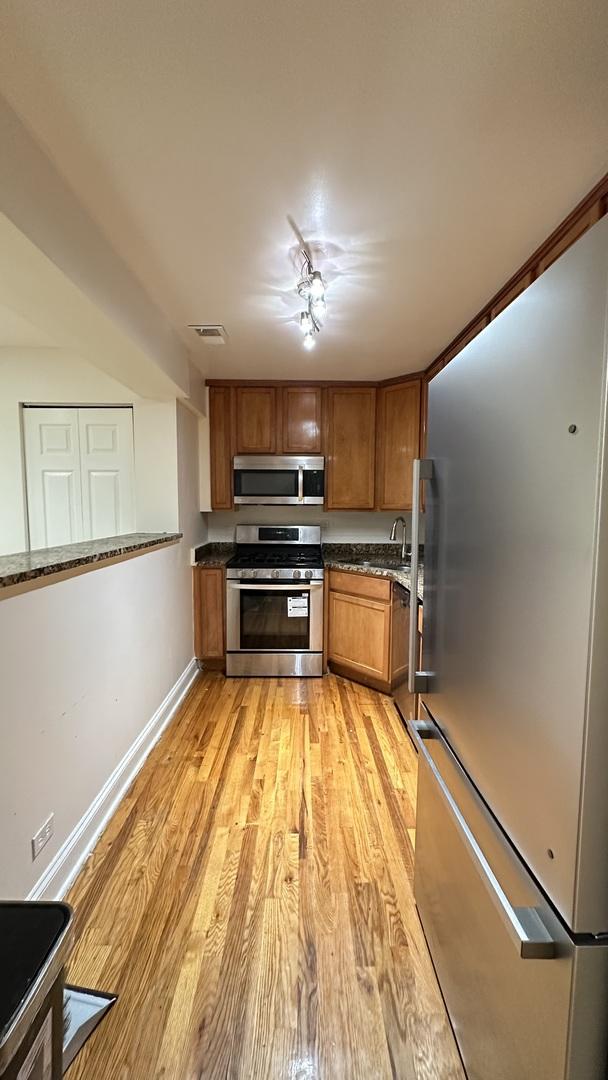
[[0, 0, 608, 378]]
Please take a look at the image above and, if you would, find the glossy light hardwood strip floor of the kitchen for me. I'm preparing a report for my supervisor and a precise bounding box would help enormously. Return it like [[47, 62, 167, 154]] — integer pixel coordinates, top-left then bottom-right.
[[68, 674, 464, 1080]]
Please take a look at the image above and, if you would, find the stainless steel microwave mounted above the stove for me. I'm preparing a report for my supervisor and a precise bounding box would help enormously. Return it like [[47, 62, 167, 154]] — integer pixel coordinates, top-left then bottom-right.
[[233, 455, 325, 507]]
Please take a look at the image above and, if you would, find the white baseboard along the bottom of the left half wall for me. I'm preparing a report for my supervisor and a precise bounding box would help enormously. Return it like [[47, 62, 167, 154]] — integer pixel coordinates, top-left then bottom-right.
[[27, 660, 198, 900]]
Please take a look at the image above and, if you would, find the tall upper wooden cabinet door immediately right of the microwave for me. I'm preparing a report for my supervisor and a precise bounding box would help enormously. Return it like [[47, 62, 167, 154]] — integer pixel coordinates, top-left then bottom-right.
[[325, 387, 376, 510]]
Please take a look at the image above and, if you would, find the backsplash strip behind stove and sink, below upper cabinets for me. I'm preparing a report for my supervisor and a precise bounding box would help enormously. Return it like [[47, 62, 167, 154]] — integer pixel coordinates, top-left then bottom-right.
[[204, 507, 422, 543]]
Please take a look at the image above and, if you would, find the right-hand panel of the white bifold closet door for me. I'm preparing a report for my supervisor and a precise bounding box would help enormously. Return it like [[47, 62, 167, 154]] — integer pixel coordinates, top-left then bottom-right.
[[78, 408, 135, 540]]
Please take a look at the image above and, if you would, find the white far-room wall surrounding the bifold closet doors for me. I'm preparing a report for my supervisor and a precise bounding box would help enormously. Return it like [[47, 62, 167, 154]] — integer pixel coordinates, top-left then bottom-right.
[[0, 349, 183, 555]]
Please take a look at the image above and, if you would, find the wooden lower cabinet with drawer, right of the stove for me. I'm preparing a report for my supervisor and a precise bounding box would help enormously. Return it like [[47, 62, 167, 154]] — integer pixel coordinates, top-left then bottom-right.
[[327, 570, 409, 692]]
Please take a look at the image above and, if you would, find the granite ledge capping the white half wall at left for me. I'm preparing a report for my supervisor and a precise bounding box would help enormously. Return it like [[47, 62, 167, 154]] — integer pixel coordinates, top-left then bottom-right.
[[0, 532, 181, 589]]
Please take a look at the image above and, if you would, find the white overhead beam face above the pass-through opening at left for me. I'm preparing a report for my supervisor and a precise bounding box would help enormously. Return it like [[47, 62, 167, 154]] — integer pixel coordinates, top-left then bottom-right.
[[0, 98, 190, 394]]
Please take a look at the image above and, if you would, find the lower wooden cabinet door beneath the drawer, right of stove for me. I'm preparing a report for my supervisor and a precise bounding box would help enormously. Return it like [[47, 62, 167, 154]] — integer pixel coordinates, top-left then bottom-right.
[[328, 592, 391, 683]]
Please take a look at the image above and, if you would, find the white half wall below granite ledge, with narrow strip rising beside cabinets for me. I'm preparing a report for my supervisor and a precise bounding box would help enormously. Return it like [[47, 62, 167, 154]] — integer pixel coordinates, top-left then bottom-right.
[[0, 404, 204, 897]]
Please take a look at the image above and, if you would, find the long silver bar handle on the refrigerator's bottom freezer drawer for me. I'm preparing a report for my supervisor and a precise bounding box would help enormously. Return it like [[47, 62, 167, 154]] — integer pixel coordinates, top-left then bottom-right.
[[414, 723, 556, 960]]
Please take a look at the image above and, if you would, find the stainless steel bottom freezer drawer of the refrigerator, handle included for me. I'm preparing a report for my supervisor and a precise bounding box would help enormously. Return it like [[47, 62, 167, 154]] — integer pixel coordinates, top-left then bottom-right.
[[415, 726, 608, 1080]]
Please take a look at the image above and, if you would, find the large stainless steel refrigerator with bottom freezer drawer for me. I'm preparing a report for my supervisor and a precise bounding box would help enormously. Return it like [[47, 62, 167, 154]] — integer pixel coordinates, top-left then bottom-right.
[[410, 212, 608, 1080]]
